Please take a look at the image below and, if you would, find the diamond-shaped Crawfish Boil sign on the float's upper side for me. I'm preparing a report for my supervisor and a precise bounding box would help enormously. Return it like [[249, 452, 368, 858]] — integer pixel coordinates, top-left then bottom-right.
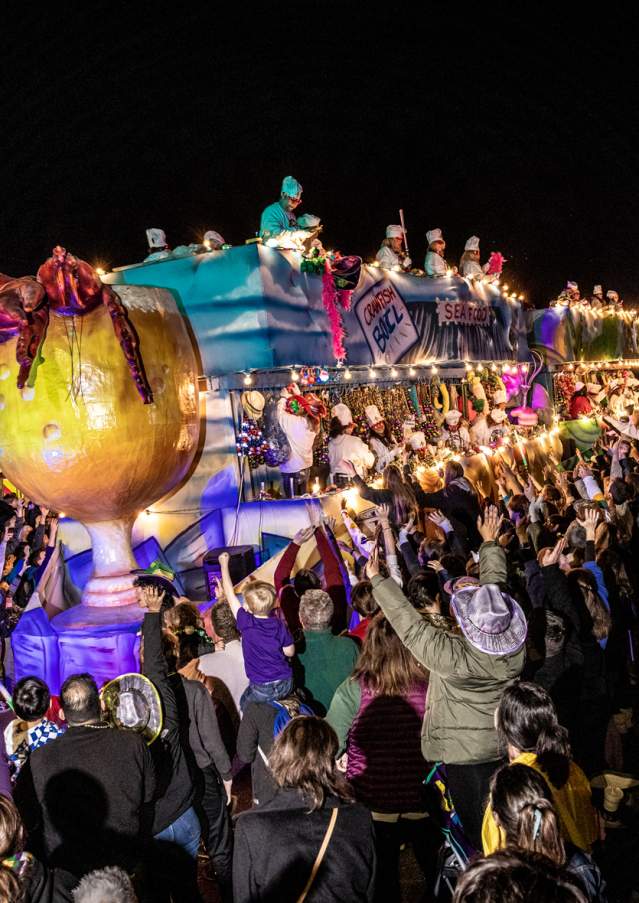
[[355, 279, 419, 364]]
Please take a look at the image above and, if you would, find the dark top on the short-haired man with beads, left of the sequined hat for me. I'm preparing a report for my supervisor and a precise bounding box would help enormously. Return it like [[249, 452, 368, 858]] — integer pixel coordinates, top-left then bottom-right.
[[15, 724, 155, 877]]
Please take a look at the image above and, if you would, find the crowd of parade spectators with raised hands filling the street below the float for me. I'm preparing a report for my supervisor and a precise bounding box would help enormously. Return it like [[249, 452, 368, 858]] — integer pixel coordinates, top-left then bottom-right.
[[0, 414, 639, 903]]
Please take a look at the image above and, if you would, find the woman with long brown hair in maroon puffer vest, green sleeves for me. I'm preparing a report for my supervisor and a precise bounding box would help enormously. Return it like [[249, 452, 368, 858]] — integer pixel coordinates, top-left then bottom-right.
[[326, 613, 440, 900]]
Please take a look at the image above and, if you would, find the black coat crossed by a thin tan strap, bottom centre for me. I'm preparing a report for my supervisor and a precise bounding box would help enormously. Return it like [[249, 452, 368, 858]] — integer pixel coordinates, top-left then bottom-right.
[[233, 790, 375, 903]]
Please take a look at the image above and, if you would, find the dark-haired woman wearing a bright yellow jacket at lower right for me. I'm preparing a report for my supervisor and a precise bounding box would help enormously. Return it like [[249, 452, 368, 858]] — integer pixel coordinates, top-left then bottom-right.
[[482, 682, 599, 853]]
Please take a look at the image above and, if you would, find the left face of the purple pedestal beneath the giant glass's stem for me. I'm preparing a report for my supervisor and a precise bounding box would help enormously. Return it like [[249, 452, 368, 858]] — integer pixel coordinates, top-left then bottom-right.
[[11, 608, 60, 695]]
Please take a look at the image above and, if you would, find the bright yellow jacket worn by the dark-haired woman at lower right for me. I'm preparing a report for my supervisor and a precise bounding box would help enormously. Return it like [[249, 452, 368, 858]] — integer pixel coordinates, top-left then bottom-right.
[[481, 753, 599, 856]]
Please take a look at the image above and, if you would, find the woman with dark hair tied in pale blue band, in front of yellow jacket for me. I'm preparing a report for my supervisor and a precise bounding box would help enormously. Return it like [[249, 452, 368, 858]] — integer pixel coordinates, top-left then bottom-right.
[[490, 765, 605, 901]]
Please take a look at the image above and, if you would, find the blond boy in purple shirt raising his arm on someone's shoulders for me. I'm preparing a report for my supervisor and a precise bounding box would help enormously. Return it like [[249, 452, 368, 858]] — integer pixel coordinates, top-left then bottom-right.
[[219, 552, 295, 711]]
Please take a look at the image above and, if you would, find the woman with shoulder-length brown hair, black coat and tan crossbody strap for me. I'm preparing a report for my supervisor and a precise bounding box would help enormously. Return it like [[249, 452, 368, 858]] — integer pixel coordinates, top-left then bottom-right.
[[233, 715, 375, 903]]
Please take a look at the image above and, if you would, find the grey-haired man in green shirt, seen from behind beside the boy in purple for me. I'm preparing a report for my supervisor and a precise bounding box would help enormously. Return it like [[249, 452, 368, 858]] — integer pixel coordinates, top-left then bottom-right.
[[297, 589, 359, 716]]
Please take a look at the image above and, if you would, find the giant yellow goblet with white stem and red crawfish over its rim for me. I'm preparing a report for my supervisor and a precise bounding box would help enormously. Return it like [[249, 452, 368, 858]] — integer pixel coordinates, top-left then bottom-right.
[[0, 248, 200, 684]]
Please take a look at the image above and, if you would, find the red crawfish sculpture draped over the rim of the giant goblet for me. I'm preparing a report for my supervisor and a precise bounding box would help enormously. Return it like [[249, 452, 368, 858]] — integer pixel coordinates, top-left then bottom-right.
[[0, 245, 153, 404]]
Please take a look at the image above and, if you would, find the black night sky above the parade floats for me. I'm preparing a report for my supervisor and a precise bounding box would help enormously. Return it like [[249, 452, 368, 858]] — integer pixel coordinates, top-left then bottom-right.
[[0, 2, 639, 306]]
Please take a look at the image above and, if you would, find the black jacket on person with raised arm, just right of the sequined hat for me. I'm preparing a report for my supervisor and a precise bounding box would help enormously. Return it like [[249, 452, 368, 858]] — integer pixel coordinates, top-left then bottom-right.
[[143, 612, 193, 835]]
